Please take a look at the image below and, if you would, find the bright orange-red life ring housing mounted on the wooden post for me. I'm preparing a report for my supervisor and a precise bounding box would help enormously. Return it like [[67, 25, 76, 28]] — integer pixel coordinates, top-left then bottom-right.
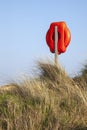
[[46, 21, 71, 54]]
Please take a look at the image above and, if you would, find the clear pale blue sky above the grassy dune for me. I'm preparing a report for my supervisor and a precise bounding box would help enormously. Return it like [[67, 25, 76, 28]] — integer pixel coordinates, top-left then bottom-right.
[[0, 0, 87, 84]]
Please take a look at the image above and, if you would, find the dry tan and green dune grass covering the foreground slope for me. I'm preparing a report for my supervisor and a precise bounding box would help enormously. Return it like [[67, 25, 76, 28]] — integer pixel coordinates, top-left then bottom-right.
[[0, 62, 87, 130]]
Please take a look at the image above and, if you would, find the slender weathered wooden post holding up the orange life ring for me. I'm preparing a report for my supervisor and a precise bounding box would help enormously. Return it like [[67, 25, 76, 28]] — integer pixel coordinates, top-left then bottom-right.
[[54, 26, 58, 65]]
